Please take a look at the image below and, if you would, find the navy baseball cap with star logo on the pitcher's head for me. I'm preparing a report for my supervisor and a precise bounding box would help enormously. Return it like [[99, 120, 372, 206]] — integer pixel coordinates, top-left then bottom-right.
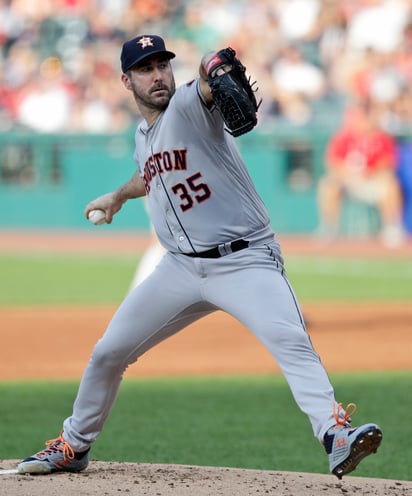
[[120, 34, 176, 72]]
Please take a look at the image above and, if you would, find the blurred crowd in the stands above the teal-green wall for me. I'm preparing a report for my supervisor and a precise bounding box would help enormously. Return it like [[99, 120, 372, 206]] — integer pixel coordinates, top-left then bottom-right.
[[0, 0, 412, 134]]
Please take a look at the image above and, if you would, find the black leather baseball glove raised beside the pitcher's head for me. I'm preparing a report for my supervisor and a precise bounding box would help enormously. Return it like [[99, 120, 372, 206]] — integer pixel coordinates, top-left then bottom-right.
[[206, 47, 262, 136]]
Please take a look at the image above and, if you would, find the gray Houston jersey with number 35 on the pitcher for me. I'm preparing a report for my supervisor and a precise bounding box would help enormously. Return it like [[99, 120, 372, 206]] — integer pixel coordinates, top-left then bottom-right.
[[134, 80, 272, 253]]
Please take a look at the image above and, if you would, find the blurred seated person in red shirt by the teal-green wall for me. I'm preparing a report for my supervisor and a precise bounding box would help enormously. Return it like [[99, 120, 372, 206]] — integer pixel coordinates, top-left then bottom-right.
[[318, 103, 404, 246]]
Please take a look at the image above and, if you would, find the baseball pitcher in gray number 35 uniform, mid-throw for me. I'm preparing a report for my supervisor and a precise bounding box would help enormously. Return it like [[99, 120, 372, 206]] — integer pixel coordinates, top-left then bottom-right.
[[18, 35, 382, 478]]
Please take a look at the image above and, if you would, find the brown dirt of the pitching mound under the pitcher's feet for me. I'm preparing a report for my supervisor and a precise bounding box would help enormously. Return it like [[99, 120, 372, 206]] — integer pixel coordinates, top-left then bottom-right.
[[0, 460, 412, 496]]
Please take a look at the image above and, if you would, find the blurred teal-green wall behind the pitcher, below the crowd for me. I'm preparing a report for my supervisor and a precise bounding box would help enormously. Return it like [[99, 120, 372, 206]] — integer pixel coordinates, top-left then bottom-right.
[[0, 128, 412, 233]]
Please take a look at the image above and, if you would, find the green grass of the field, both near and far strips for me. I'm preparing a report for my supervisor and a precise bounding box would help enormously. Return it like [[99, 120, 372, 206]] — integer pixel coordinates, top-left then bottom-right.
[[0, 255, 412, 480]]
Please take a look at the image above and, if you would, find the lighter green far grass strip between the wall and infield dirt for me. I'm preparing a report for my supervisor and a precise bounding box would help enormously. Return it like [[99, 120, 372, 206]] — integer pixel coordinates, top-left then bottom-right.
[[0, 255, 412, 306]]
